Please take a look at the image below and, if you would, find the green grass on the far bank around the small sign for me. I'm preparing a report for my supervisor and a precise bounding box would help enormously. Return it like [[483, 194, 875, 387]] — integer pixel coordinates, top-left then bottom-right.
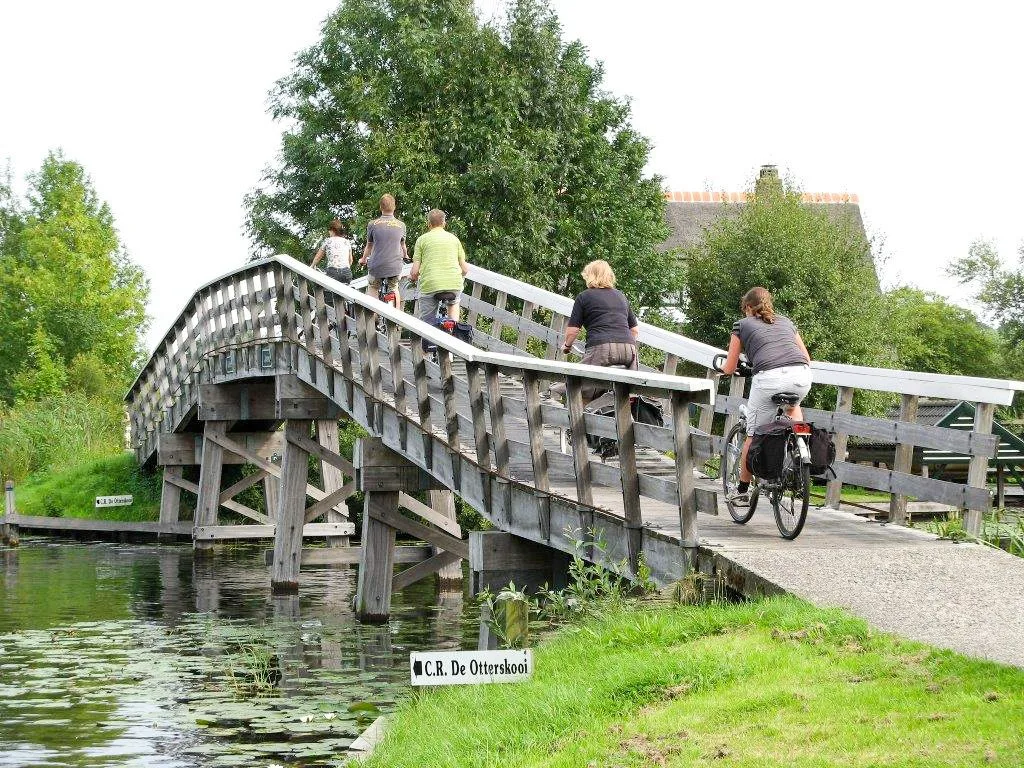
[[14, 452, 161, 522]]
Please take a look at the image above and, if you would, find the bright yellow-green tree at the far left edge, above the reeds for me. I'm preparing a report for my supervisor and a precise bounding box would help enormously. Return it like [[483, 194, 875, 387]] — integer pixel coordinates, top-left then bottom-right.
[[0, 152, 148, 402]]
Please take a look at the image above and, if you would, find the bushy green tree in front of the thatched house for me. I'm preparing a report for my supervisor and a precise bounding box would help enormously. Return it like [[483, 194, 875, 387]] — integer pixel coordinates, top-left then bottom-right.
[[683, 177, 896, 404]]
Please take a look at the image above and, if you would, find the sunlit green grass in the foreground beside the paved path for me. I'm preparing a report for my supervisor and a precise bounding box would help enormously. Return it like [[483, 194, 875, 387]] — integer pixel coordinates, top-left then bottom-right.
[[367, 598, 1024, 768]]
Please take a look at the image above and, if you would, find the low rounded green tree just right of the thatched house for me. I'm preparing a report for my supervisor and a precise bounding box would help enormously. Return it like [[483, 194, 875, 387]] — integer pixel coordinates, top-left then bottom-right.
[[886, 287, 1002, 377]]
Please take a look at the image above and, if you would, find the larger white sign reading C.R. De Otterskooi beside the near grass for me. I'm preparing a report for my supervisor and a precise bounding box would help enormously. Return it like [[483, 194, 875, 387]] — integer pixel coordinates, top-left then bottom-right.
[[409, 648, 534, 685]]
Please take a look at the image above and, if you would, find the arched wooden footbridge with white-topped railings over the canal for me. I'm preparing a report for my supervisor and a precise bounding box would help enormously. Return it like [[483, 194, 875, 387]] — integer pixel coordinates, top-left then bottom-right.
[[116, 256, 1024, 634]]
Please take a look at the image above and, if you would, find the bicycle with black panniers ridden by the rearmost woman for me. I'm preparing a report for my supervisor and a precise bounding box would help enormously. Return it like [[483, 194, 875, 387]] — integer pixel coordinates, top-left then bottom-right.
[[712, 354, 811, 540]]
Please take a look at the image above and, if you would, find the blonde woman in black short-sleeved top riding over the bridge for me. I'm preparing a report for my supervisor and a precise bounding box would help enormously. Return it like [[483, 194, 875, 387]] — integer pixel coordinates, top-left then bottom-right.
[[550, 260, 640, 399]]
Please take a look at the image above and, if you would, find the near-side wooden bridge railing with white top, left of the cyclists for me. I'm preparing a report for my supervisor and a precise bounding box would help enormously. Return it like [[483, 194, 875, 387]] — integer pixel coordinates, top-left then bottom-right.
[[126, 256, 717, 566]]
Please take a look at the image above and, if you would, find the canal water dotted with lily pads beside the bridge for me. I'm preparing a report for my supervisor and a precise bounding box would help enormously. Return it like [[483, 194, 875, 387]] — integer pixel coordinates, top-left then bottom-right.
[[0, 539, 478, 768]]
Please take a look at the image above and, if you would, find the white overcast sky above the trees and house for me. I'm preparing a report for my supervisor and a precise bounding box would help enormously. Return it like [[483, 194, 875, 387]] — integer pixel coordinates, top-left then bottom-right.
[[0, 0, 1024, 347]]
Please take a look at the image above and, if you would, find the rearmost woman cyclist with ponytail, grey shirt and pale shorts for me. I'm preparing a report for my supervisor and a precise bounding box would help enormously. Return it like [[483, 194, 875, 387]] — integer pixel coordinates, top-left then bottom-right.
[[722, 288, 811, 507]]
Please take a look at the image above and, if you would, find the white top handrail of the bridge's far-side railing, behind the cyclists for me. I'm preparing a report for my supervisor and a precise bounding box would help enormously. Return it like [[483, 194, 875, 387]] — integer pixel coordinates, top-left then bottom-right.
[[468, 266, 1024, 406]]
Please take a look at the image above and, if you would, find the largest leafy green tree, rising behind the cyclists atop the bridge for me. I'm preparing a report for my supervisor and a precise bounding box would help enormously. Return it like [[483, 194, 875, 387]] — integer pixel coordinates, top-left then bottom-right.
[[247, 0, 681, 306]]
